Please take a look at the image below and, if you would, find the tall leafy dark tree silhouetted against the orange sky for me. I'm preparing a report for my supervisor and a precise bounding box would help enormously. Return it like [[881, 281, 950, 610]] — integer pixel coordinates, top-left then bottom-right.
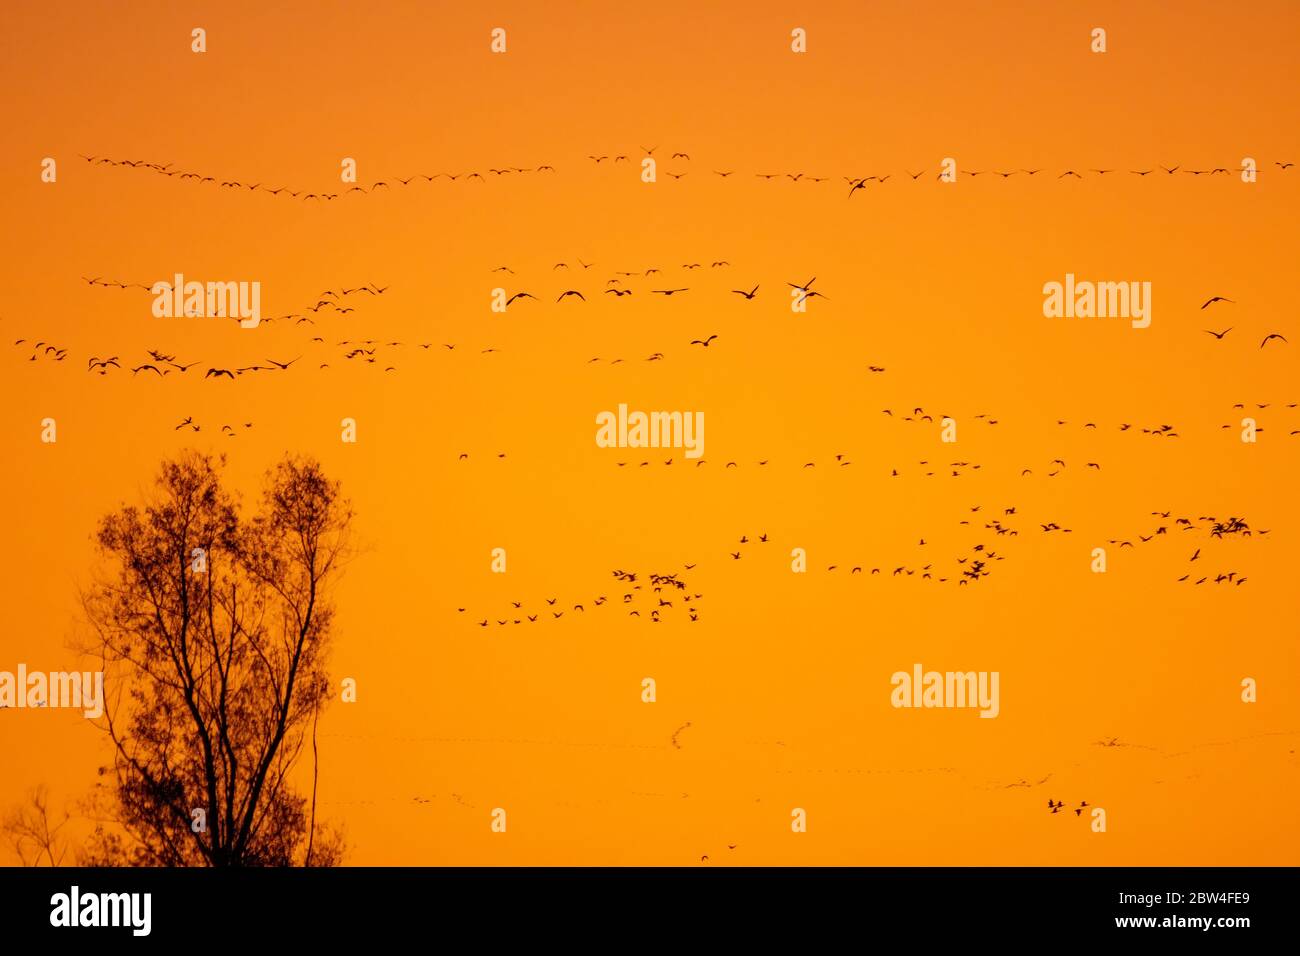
[[83, 453, 352, 866]]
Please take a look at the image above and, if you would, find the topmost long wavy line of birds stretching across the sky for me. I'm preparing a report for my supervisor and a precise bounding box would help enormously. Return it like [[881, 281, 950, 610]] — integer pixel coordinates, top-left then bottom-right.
[[78, 146, 1295, 203]]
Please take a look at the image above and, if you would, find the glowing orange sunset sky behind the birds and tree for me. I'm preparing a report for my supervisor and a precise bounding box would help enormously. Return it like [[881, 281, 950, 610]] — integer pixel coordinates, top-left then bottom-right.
[[0, 0, 1300, 865]]
